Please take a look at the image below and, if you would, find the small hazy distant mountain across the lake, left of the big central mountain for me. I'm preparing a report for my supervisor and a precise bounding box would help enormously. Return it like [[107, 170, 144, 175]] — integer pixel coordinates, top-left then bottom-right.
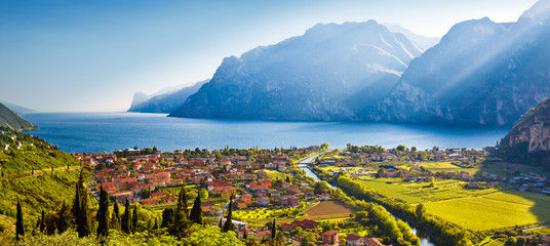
[[128, 80, 208, 113]]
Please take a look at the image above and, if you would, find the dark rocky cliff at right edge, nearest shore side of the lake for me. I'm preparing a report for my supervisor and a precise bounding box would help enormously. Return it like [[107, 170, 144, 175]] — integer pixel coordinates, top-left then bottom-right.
[[498, 98, 550, 168]]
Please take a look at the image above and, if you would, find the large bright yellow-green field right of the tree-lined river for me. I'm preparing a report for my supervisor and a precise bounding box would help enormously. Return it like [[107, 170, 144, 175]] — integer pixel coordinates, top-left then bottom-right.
[[362, 178, 550, 231]]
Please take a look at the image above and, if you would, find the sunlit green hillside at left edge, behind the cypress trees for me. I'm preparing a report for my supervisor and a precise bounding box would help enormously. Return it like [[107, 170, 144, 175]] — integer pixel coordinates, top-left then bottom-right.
[[0, 127, 80, 231]]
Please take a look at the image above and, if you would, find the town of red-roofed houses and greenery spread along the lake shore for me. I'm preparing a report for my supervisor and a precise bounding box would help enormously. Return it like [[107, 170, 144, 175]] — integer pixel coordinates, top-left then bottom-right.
[[74, 145, 549, 245]]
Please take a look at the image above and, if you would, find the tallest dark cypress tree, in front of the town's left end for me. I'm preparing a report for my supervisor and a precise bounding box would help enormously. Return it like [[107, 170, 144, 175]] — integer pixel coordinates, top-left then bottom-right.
[[73, 170, 91, 237]]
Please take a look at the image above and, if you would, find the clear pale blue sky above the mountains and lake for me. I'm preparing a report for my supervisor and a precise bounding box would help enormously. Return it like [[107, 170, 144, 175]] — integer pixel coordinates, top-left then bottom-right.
[[0, 0, 535, 112]]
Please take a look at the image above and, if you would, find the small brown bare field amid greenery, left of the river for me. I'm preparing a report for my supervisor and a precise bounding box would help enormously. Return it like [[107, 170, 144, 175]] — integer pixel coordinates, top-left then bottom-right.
[[304, 201, 353, 220]]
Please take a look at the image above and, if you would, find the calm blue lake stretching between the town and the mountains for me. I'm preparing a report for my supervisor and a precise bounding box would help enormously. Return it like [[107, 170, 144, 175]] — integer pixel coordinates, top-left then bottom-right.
[[24, 113, 506, 152]]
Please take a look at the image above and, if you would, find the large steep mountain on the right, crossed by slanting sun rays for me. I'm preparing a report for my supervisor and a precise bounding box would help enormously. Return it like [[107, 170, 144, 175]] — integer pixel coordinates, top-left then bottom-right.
[[376, 0, 550, 126]]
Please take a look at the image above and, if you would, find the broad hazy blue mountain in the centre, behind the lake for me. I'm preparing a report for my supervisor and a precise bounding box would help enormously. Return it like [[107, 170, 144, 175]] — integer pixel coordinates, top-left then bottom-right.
[[171, 21, 421, 121]]
